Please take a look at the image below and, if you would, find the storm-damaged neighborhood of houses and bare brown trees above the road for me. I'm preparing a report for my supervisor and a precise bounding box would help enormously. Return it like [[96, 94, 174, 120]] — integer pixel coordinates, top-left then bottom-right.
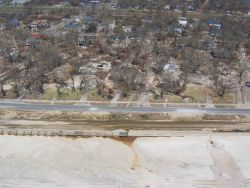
[[0, 0, 250, 104]]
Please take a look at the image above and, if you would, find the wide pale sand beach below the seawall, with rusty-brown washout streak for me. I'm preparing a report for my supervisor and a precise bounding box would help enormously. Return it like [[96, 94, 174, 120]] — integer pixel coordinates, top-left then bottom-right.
[[0, 133, 250, 188]]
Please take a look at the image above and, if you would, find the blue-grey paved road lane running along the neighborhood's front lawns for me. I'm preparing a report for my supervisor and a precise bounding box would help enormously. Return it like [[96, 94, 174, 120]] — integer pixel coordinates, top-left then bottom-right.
[[0, 101, 250, 115]]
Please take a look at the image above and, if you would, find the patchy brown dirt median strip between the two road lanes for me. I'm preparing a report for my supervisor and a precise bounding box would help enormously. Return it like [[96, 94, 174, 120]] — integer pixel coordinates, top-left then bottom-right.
[[0, 110, 247, 125]]
